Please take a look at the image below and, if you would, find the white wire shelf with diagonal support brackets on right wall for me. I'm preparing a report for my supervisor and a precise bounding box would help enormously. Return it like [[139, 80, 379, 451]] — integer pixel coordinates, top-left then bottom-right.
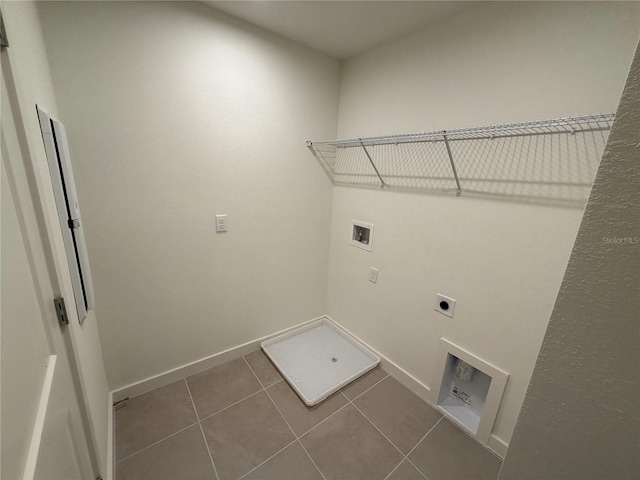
[[307, 114, 614, 203]]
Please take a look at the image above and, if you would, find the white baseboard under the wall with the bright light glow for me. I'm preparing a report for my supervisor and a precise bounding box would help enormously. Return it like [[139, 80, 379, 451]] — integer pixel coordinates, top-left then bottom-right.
[[111, 315, 325, 404]]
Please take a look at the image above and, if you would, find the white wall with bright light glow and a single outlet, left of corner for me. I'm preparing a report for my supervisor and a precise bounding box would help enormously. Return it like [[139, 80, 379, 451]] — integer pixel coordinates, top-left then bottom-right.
[[40, 2, 339, 389]]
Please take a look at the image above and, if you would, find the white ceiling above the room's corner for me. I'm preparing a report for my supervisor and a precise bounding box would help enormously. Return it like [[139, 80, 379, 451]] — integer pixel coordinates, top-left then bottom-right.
[[204, 0, 473, 59]]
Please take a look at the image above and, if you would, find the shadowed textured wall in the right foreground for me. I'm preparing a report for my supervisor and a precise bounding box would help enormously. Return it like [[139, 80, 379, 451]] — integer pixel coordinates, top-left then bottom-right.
[[500, 44, 640, 480]]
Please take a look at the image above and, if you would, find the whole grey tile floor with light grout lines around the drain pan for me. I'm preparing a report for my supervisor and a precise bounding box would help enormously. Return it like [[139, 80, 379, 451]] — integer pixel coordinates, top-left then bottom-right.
[[115, 351, 501, 480]]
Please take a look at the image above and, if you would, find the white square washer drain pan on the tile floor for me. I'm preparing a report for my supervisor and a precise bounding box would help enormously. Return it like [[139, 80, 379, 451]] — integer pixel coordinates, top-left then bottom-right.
[[262, 319, 380, 406]]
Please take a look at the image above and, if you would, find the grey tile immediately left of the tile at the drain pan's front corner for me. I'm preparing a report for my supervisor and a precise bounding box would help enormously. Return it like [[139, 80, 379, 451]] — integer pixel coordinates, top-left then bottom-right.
[[202, 391, 295, 480]]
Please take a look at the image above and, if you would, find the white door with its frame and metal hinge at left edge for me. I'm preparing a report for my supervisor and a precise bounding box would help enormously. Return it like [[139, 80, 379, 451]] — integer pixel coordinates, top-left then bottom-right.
[[0, 10, 108, 480]]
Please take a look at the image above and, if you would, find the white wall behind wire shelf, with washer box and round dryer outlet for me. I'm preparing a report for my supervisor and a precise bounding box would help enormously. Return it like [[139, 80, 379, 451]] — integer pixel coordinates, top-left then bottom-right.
[[328, 2, 640, 451]]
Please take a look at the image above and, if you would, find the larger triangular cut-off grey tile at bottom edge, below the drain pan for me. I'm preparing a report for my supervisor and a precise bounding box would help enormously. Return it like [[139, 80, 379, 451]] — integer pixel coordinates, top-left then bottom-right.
[[243, 442, 322, 480]]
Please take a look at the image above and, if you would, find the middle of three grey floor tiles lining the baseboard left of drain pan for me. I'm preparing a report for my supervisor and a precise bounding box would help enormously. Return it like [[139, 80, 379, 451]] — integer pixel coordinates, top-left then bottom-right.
[[187, 357, 262, 419]]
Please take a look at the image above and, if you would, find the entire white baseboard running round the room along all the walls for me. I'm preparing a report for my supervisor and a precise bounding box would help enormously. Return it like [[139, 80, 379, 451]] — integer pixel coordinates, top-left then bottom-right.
[[107, 315, 508, 460]]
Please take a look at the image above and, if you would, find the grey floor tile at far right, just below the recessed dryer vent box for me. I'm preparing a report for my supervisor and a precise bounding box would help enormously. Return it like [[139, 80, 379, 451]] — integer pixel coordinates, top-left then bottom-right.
[[409, 418, 502, 480]]
